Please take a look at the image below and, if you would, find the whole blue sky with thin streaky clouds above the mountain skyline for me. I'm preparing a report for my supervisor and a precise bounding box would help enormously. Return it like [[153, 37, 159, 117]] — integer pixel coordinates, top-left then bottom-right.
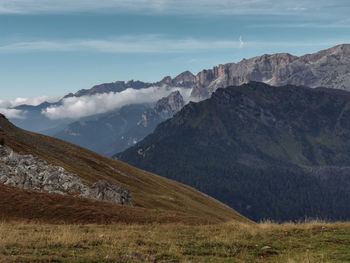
[[0, 0, 350, 100]]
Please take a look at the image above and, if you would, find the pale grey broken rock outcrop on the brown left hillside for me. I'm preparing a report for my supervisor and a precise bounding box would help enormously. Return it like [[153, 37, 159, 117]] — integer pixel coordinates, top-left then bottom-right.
[[0, 145, 133, 206]]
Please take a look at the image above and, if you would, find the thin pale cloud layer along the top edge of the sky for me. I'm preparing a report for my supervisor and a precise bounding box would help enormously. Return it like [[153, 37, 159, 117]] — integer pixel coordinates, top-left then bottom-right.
[[0, 0, 349, 14]]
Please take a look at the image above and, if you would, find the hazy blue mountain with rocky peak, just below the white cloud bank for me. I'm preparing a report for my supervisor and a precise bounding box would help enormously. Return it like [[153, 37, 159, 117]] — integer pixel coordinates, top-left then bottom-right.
[[53, 91, 184, 156]]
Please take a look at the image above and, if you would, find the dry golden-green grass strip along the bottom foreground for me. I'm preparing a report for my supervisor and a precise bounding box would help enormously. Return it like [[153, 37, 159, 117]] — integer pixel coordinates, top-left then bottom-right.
[[0, 222, 350, 263]]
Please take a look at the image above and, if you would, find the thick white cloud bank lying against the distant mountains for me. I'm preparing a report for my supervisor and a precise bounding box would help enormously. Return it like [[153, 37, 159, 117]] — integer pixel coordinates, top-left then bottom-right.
[[42, 87, 191, 120]]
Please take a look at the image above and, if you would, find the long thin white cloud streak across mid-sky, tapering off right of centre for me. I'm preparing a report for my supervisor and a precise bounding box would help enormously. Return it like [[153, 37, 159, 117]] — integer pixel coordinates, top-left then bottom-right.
[[0, 36, 245, 53]]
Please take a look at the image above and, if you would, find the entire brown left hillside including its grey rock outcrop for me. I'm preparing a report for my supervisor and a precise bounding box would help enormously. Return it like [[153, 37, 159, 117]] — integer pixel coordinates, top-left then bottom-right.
[[0, 115, 249, 224]]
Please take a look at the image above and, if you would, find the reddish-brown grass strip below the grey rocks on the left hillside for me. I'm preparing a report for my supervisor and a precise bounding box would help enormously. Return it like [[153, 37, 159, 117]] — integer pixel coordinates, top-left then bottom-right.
[[0, 184, 211, 225]]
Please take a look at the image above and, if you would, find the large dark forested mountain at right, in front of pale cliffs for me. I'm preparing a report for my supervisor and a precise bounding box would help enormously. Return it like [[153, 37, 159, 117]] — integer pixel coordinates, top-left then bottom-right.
[[116, 82, 350, 221]]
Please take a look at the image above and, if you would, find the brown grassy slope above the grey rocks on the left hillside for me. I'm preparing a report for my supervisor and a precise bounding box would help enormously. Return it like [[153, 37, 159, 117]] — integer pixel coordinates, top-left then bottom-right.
[[0, 116, 247, 223]]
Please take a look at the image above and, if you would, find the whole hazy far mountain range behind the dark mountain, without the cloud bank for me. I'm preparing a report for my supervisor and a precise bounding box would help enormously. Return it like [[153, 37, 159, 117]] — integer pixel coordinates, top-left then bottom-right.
[[11, 44, 350, 156]]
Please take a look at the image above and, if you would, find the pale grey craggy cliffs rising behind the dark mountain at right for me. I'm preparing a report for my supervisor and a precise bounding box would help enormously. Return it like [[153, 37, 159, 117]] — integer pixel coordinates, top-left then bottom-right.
[[191, 44, 350, 100]]
